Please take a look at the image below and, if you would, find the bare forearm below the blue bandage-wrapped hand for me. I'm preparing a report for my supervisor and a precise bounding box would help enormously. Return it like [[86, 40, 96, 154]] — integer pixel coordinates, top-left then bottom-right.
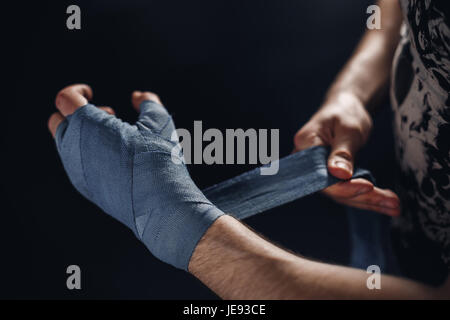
[[189, 216, 437, 299]]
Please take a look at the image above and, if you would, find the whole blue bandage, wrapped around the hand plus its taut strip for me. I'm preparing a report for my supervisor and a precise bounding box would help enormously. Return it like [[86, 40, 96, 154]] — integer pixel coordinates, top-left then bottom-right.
[[55, 101, 371, 270]]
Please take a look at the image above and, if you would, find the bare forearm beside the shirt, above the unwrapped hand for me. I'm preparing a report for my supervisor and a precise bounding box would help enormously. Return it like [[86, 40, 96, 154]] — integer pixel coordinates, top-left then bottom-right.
[[325, 0, 402, 111]]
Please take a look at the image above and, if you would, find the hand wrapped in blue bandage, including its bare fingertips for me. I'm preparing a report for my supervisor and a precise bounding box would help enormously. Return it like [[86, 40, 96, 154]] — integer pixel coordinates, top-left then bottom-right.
[[48, 84, 223, 270]]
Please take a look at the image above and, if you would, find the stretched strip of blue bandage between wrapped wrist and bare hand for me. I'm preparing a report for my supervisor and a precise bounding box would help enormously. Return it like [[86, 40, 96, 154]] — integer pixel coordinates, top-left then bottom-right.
[[202, 146, 374, 219]]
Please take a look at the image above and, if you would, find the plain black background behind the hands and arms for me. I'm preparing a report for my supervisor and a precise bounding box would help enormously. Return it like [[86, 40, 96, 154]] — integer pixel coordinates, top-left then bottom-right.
[[4, 0, 394, 299]]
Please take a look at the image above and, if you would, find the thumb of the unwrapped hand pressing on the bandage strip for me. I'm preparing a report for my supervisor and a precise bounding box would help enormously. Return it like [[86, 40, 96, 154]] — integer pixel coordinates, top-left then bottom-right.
[[328, 132, 361, 180]]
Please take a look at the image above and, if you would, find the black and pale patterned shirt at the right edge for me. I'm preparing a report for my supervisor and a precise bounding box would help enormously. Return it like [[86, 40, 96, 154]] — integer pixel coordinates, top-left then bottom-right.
[[391, 0, 450, 284]]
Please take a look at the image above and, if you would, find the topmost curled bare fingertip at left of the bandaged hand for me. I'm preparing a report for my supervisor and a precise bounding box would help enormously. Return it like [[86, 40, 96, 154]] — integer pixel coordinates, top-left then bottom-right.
[[55, 84, 92, 117]]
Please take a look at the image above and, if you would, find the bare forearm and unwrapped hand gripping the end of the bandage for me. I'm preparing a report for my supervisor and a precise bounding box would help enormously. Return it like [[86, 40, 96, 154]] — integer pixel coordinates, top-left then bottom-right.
[[294, 0, 402, 216]]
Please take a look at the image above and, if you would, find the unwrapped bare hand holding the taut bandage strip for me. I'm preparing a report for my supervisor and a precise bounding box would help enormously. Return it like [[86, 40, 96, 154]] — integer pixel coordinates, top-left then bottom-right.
[[294, 94, 400, 216]]
